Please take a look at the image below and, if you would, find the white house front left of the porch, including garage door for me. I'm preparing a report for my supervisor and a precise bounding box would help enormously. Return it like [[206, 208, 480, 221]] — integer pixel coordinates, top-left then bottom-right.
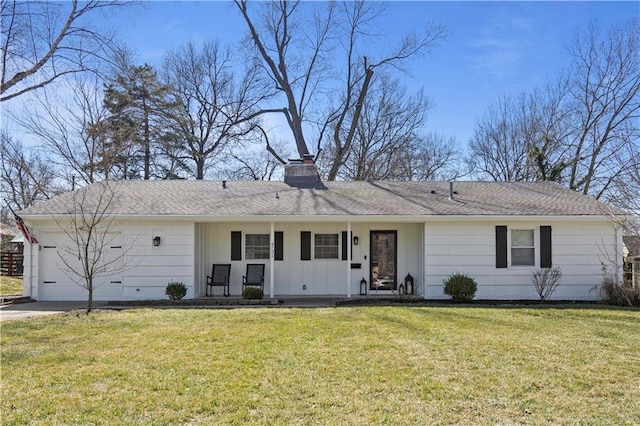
[[24, 220, 195, 301]]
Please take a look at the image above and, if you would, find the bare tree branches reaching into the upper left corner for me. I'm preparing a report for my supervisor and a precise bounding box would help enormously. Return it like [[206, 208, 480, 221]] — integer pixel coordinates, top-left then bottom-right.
[[0, 0, 125, 101]]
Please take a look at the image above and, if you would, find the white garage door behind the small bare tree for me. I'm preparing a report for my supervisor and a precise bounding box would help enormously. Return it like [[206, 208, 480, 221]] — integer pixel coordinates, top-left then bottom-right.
[[38, 232, 123, 300]]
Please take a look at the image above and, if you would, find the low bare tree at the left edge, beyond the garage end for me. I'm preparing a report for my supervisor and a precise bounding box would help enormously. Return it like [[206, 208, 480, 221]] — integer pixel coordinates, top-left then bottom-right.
[[0, 130, 57, 210]]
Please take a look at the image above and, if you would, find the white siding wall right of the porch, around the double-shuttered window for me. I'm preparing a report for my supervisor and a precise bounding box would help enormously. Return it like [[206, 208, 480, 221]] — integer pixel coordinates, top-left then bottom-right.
[[424, 220, 620, 300]]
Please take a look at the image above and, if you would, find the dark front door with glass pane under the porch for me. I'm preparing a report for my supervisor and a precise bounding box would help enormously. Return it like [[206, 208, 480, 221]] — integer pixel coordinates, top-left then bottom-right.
[[369, 231, 398, 291]]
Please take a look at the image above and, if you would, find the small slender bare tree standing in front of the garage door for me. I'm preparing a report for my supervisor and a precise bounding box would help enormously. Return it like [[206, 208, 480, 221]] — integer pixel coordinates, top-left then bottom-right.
[[55, 181, 135, 313]]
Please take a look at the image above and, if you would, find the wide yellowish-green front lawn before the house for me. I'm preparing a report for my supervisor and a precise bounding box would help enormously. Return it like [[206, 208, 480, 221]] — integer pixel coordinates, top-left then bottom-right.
[[0, 306, 640, 425]]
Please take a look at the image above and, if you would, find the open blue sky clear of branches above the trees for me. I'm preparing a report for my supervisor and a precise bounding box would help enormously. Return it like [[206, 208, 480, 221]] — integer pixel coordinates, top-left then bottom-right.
[[97, 1, 640, 147]]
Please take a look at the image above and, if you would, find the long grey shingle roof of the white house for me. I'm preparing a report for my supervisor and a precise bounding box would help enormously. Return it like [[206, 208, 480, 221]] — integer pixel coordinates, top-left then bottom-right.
[[21, 180, 623, 219]]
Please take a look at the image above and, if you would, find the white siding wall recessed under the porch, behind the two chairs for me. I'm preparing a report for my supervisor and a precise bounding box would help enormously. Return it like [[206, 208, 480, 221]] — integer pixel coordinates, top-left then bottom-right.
[[195, 222, 423, 296]]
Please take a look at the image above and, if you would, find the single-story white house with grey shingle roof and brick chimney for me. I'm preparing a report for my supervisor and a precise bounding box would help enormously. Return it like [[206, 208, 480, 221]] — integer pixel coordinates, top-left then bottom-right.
[[19, 162, 624, 300]]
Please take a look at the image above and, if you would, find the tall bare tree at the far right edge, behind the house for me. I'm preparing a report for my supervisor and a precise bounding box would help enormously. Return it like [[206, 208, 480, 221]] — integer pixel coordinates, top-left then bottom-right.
[[566, 18, 640, 198]]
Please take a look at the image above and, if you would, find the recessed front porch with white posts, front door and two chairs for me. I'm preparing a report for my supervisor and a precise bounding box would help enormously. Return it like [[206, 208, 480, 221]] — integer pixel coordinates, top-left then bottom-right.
[[193, 221, 424, 303]]
